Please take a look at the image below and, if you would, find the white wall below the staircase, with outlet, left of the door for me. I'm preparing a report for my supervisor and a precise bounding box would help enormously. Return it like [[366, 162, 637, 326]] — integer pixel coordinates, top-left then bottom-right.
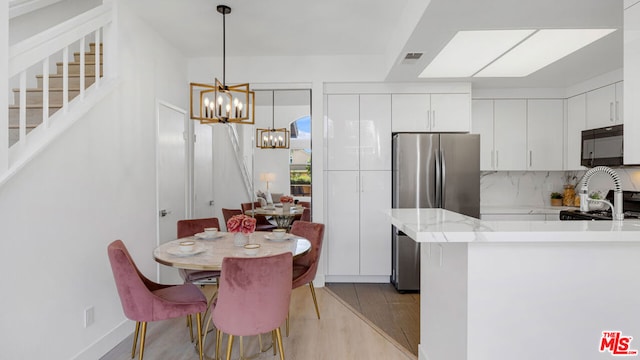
[[0, 4, 187, 359]]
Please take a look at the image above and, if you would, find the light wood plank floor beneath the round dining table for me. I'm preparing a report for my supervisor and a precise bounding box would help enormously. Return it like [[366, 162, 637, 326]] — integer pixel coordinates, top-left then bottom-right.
[[102, 286, 417, 360]]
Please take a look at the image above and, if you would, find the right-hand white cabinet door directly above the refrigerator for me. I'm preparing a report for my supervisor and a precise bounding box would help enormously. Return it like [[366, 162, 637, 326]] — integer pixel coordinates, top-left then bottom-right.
[[431, 94, 471, 132]]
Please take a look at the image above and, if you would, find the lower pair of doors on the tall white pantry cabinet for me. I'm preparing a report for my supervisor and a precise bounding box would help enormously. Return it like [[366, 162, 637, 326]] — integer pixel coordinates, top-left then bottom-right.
[[325, 171, 391, 276]]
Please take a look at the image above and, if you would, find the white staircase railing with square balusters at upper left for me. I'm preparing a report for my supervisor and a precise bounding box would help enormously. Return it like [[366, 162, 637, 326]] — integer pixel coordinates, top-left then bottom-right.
[[0, 3, 116, 184]]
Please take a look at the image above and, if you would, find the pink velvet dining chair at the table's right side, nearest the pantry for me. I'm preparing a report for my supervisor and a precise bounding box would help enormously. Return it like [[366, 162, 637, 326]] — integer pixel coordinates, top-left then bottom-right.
[[287, 220, 324, 336]]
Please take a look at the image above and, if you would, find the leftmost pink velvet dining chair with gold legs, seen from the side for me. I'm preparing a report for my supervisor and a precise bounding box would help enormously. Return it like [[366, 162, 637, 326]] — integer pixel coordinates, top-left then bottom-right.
[[107, 240, 207, 360]]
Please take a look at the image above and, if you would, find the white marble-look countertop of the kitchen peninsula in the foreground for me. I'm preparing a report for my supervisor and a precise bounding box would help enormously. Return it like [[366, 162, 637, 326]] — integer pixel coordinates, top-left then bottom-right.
[[388, 209, 640, 242]]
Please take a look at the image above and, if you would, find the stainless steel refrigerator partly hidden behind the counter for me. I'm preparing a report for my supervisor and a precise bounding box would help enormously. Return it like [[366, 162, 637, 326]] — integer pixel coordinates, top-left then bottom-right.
[[391, 133, 480, 291]]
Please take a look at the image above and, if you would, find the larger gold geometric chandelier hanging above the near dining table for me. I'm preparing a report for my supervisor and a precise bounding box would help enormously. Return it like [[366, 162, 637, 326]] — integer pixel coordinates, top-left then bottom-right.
[[189, 5, 256, 124]]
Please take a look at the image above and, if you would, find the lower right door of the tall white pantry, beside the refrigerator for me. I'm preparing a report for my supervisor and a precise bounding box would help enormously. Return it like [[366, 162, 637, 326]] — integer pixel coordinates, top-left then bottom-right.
[[360, 171, 391, 276]]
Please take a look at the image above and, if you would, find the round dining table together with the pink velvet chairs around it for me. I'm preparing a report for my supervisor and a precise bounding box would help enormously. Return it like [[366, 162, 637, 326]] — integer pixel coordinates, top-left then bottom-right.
[[108, 214, 324, 360]]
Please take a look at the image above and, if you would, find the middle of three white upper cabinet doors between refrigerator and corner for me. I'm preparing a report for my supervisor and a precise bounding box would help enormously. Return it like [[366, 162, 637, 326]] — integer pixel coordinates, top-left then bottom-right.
[[493, 100, 527, 170]]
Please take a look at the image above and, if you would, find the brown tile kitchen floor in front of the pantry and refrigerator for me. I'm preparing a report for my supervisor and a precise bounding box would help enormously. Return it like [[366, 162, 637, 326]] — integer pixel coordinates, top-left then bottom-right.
[[326, 283, 420, 356]]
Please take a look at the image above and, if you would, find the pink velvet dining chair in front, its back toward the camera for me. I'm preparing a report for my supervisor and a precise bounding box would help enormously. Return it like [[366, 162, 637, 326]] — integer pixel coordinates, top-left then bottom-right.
[[211, 252, 293, 360]]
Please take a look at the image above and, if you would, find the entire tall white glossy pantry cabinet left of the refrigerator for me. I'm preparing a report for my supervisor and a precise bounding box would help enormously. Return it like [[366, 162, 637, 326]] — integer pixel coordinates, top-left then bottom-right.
[[325, 94, 391, 280]]
